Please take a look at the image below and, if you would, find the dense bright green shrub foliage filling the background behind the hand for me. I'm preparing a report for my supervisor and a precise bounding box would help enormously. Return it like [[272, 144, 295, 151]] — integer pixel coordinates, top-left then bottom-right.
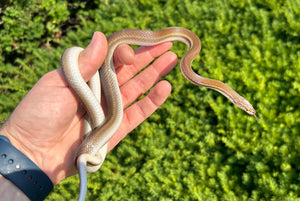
[[0, 0, 300, 200]]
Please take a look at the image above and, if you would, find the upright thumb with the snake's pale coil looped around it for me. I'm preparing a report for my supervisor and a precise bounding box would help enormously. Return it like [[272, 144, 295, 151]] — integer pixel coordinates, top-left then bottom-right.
[[78, 32, 107, 81]]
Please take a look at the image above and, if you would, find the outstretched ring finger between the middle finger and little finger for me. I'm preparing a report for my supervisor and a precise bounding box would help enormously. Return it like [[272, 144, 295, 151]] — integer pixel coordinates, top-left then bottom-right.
[[120, 52, 177, 108]]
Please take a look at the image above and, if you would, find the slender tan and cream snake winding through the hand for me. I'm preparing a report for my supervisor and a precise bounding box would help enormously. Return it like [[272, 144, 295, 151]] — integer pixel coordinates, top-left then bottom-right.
[[61, 27, 257, 200]]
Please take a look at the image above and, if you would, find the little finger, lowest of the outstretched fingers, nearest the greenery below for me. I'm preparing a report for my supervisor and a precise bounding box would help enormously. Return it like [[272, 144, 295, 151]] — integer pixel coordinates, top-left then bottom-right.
[[108, 81, 171, 151]]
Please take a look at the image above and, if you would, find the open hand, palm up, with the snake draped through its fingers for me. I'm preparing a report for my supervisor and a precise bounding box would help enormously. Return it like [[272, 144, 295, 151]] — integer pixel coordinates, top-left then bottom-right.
[[0, 32, 177, 185]]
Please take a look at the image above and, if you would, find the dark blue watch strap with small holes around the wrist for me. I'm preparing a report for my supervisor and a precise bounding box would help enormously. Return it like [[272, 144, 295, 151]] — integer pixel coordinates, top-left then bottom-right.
[[0, 135, 53, 201]]
